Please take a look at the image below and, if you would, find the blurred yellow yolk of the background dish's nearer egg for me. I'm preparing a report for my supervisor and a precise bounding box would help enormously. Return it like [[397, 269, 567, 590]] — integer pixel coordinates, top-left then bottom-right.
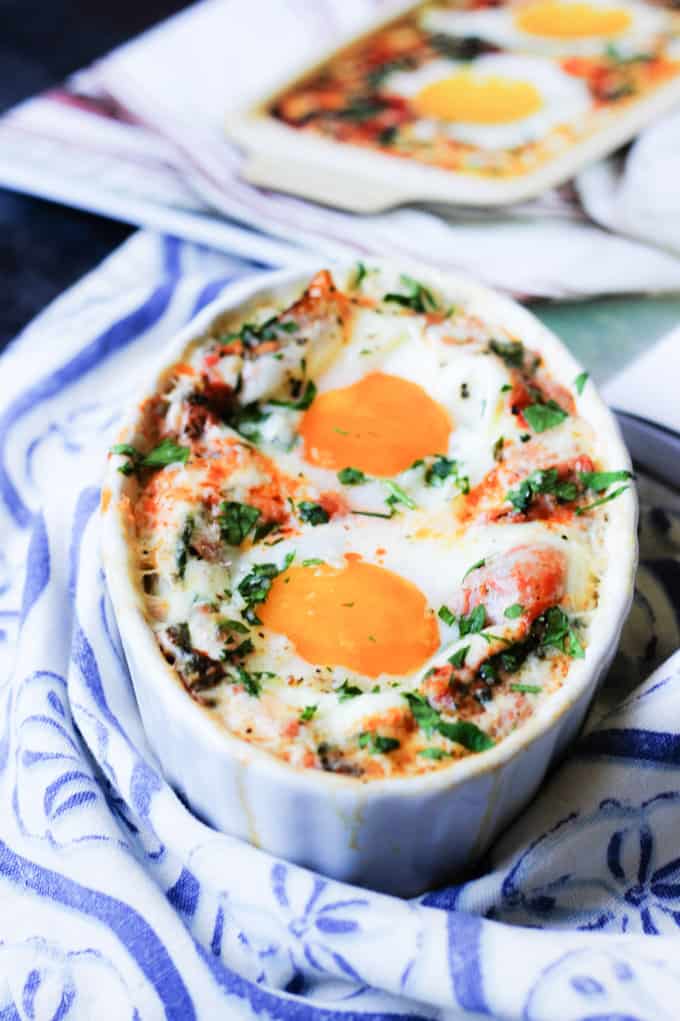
[[412, 70, 543, 125]]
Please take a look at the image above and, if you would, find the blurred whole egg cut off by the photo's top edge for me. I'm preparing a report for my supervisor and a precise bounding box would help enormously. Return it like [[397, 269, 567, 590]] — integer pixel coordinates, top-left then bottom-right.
[[422, 0, 670, 57]]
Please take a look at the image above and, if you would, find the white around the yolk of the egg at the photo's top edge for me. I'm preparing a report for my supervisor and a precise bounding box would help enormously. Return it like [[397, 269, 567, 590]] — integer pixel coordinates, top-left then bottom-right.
[[422, 0, 669, 57]]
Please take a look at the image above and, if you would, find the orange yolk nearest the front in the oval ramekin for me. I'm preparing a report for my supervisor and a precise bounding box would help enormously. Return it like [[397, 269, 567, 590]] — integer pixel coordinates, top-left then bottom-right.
[[257, 561, 439, 677]]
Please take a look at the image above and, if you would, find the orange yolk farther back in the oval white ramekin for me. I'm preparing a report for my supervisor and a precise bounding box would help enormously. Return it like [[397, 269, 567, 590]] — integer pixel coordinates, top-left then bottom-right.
[[299, 373, 451, 476]]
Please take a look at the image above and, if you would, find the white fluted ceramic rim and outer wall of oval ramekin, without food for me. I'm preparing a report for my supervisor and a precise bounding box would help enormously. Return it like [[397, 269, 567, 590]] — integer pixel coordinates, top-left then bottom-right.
[[101, 260, 637, 896]]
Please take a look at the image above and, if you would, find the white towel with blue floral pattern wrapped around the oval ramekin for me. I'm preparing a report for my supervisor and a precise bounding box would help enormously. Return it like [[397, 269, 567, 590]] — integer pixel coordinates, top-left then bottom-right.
[[0, 234, 680, 1021]]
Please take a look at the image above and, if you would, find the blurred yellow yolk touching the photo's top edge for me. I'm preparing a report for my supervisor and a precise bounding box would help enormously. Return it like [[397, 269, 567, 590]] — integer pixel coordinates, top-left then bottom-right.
[[515, 0, 631, 39]]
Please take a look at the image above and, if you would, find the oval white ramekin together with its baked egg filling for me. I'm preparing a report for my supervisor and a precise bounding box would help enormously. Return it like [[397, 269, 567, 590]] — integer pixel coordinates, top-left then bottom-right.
[[102, 261, 636, 895]]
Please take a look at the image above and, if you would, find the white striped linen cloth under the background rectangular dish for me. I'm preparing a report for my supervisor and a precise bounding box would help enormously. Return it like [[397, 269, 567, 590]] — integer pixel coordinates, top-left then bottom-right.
[[0, 0, 680, 298]]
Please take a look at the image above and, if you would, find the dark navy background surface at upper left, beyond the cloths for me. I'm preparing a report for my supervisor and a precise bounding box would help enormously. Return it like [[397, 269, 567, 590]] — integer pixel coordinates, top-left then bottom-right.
[[0, 0, 189, 350]]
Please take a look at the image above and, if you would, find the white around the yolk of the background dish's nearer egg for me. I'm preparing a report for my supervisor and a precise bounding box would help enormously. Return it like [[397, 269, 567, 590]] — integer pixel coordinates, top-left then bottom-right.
[[383, 54, 591, 149]]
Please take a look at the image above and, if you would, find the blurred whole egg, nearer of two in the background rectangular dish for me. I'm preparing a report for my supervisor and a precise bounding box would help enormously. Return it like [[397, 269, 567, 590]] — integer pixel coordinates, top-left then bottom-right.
[[382, 52, 591, 149]]
